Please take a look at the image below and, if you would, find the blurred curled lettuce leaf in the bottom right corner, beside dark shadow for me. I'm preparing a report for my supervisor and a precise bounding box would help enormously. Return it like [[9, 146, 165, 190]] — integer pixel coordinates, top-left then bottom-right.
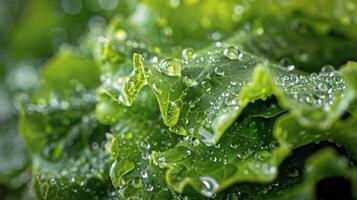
[[227, 146, 357, 200]]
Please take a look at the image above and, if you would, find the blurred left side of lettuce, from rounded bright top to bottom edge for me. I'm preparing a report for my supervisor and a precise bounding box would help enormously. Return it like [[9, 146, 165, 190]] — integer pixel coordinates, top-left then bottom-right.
[[20, 50, 116, 199]]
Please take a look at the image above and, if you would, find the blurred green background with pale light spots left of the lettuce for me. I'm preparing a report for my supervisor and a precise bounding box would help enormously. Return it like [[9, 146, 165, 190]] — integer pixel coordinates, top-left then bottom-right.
[[0, 0, 132, 199]]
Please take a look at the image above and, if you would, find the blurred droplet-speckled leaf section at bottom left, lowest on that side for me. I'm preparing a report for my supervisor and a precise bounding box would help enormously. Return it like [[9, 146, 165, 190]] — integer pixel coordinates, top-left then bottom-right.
[[33, 146, 117, 200]]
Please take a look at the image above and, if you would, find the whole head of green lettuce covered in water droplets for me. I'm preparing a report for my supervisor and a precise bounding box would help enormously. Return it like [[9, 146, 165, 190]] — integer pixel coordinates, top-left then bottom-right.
[[13, 0, 357, 199]]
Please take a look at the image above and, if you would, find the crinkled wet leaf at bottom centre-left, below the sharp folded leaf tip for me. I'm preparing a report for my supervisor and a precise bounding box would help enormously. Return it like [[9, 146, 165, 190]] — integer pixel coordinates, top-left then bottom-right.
[[96, 83, 178, 199]]
